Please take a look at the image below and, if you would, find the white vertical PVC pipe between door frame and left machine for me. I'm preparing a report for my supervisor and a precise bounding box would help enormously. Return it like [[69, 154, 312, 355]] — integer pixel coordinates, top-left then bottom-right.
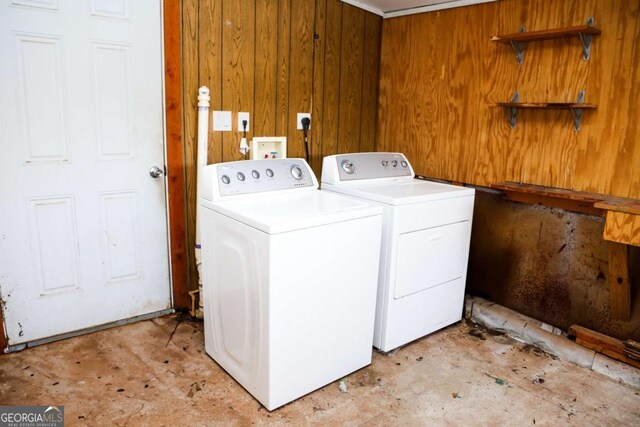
[[195, 86, 210, 318]]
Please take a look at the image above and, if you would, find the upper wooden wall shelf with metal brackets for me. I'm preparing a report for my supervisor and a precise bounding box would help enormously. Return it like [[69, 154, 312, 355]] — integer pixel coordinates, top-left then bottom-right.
[[491, 17, 602, 64]]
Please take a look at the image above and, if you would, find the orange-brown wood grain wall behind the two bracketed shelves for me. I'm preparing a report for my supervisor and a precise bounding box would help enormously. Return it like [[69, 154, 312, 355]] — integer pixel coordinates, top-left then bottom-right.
[[377, 0, 640, 198]]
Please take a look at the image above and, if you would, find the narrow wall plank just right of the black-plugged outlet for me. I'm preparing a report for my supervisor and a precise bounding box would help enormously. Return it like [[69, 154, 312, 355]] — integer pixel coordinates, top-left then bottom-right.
[[309, 0, 327, 178]]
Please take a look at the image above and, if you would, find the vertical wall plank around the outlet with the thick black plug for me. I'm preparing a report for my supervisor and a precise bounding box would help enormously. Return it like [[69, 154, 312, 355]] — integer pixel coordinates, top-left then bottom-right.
[[287, 0, 315, 158]]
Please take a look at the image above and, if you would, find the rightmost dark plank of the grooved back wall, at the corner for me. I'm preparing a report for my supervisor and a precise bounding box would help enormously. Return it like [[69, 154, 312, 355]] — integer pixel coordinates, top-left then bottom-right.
[[359, 13, 382, 152]]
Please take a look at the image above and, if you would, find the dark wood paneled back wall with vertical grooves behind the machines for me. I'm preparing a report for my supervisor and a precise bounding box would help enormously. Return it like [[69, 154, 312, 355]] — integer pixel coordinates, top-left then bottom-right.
[[182, 0, 382, 289]]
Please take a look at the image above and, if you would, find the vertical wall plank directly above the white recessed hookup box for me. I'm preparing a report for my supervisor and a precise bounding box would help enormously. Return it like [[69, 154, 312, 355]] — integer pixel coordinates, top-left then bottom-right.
[[252, 0, 278, 136]]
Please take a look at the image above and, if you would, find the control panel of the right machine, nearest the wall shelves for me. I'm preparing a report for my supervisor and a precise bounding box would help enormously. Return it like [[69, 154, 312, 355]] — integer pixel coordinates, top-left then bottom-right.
[[322, 153, 414, 184]]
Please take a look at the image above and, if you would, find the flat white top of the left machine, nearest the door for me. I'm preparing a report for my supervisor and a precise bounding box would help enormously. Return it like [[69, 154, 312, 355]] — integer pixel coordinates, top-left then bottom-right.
[[202, 191, 382, 234]]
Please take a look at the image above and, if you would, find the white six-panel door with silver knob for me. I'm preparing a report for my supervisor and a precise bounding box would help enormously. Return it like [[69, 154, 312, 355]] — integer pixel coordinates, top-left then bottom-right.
[[0, 0, 171, 345]]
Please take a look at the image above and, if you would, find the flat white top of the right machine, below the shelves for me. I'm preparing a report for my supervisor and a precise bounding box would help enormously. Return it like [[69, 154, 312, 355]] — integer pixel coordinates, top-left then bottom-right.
[[322, 179, 475, 205]]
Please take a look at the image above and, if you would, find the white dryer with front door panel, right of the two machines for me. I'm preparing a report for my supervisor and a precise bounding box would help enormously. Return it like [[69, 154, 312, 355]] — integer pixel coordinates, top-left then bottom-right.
[[322, 153, 475, 351]]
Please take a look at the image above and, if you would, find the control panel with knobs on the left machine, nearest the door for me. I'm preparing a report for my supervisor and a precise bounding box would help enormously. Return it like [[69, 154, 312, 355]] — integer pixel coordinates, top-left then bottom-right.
[[214, 159, 316, 196]]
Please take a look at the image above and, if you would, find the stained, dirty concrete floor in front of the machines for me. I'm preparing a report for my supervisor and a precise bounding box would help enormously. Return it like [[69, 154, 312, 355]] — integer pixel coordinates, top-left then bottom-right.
[[0, 316, 640, 426]]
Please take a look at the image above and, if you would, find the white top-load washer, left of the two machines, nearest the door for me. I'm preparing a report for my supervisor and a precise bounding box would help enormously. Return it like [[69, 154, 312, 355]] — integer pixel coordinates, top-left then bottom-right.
[[200, 159, 382, 410]]
